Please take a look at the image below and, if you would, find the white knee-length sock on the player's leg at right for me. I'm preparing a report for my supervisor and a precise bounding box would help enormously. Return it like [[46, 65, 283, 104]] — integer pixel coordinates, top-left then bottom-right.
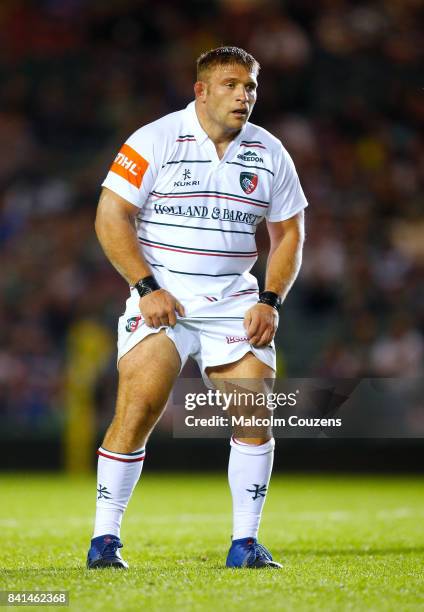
[[228, 437, 275, 540]]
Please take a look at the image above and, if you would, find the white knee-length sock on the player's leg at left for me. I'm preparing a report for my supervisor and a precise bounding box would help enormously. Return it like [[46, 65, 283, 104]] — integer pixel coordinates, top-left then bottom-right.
[[93, 447, 145, 538]]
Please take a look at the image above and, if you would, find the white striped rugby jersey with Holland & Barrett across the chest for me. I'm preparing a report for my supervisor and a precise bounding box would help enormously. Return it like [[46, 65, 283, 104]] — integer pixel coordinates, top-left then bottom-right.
[[103, 102, 307, 313]]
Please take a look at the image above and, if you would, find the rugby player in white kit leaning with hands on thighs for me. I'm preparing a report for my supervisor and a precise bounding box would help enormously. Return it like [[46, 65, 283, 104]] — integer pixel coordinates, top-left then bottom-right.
[[87, 47, 307, 569]]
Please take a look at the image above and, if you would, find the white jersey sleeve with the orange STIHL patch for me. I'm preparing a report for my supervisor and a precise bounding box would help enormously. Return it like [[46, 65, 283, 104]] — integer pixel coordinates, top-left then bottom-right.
[[102, 128, 157, 208]]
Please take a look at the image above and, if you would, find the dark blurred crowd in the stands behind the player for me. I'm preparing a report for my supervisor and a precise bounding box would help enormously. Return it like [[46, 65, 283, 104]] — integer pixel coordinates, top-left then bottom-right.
[[0, 0, 424, 435]]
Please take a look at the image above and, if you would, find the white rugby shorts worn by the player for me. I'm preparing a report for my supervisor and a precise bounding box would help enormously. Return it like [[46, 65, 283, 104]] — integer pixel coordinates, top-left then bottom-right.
[[118, 289, 276, 387]]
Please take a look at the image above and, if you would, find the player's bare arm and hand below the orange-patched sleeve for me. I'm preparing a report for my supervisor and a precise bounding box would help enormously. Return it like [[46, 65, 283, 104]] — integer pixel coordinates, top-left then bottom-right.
[[95, 188, 184, 327]]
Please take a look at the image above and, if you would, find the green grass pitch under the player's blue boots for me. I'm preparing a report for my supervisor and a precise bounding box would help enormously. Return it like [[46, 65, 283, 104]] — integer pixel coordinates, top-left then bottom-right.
[[0, 472, 424, 612]]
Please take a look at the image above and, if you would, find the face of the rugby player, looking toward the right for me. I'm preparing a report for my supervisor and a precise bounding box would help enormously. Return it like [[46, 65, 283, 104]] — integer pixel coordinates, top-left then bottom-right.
[[203, 64, 258, 132]]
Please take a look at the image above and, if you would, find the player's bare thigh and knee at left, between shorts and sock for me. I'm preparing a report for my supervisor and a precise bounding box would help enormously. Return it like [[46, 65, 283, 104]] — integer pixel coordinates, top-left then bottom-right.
[[103, 330, 181, 453]]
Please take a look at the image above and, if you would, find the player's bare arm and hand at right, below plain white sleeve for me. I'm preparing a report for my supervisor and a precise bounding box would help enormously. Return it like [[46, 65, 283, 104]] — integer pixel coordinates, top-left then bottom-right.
[[245, 211, 304, 347]]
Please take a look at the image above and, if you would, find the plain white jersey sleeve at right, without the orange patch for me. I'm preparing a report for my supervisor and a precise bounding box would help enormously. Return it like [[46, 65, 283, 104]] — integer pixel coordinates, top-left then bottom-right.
[[266, 147, 308, 222]]
